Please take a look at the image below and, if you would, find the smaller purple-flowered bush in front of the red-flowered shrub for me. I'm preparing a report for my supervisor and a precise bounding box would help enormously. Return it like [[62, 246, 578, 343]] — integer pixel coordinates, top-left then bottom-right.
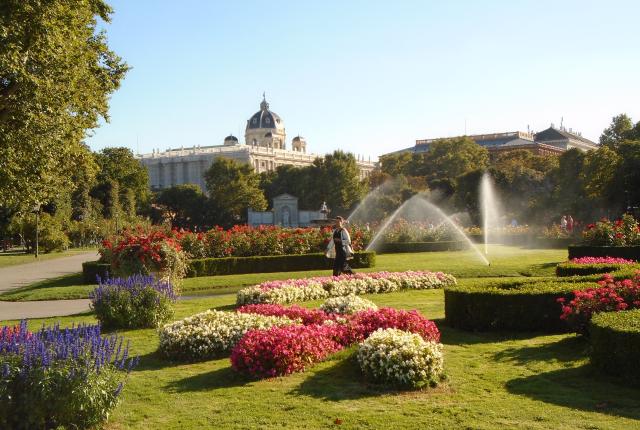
[[89, 275, 176, 328]]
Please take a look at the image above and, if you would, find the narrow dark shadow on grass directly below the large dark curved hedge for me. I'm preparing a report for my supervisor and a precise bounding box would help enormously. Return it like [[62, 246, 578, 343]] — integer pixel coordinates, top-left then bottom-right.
[[493, 336, 588, 364]]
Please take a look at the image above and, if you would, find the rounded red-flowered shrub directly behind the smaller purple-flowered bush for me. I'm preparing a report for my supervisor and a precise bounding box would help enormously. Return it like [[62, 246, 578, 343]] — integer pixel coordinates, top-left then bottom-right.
[[100, 229, 187, 285]]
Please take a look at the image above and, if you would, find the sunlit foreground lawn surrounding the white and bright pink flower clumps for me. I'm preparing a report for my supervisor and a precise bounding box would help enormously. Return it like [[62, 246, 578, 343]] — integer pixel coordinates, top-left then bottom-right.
[[2, 288, 640, 430]]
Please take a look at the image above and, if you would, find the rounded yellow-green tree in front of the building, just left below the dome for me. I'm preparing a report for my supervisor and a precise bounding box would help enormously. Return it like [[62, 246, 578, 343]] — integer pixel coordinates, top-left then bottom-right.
[[204, 157, 267, 226]]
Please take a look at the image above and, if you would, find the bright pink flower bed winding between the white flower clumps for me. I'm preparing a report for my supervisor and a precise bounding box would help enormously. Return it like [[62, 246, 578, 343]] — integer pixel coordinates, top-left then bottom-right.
[[231, 305, 440, 378]]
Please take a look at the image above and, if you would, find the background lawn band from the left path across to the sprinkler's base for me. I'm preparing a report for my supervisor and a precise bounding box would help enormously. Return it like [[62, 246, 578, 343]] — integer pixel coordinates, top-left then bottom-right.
[[0, 245, 567, 301]]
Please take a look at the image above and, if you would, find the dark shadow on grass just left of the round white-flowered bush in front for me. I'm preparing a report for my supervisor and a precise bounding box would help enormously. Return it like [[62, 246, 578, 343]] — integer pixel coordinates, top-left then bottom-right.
[[290, 349, 398, 402]]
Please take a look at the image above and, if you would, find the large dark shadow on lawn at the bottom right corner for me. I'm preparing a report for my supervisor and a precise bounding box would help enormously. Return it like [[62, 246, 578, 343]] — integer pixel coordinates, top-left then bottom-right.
[[506, 364, 640, 420]]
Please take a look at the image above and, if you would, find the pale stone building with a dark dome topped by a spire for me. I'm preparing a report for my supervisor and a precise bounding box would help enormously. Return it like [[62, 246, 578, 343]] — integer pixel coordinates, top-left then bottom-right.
[[137, 96, 375, 190]]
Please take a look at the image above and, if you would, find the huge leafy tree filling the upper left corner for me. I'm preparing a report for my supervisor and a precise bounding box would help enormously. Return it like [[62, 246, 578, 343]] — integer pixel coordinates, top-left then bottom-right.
[[0, 0, 128, 208]]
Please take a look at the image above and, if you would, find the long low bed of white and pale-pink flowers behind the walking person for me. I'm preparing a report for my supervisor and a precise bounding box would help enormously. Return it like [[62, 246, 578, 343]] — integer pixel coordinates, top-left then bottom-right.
[[236, 272, 456, 305]]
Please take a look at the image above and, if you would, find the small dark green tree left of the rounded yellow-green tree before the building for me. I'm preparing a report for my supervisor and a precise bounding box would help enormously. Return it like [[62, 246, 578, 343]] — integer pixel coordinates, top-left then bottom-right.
[[156, 184, 207, 229]]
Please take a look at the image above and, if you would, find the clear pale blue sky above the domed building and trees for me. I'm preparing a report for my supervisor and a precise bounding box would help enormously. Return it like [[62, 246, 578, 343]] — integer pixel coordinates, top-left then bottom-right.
[[88, 0, 640, 157]]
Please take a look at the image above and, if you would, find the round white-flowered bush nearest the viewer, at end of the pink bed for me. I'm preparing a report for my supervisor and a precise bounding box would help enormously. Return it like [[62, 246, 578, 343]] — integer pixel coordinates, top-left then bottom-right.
[[357, 329, 444, 388]]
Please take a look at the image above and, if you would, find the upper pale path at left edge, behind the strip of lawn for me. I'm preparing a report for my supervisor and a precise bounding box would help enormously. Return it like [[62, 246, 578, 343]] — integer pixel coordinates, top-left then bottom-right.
[[0, 251, 99, 293]]
